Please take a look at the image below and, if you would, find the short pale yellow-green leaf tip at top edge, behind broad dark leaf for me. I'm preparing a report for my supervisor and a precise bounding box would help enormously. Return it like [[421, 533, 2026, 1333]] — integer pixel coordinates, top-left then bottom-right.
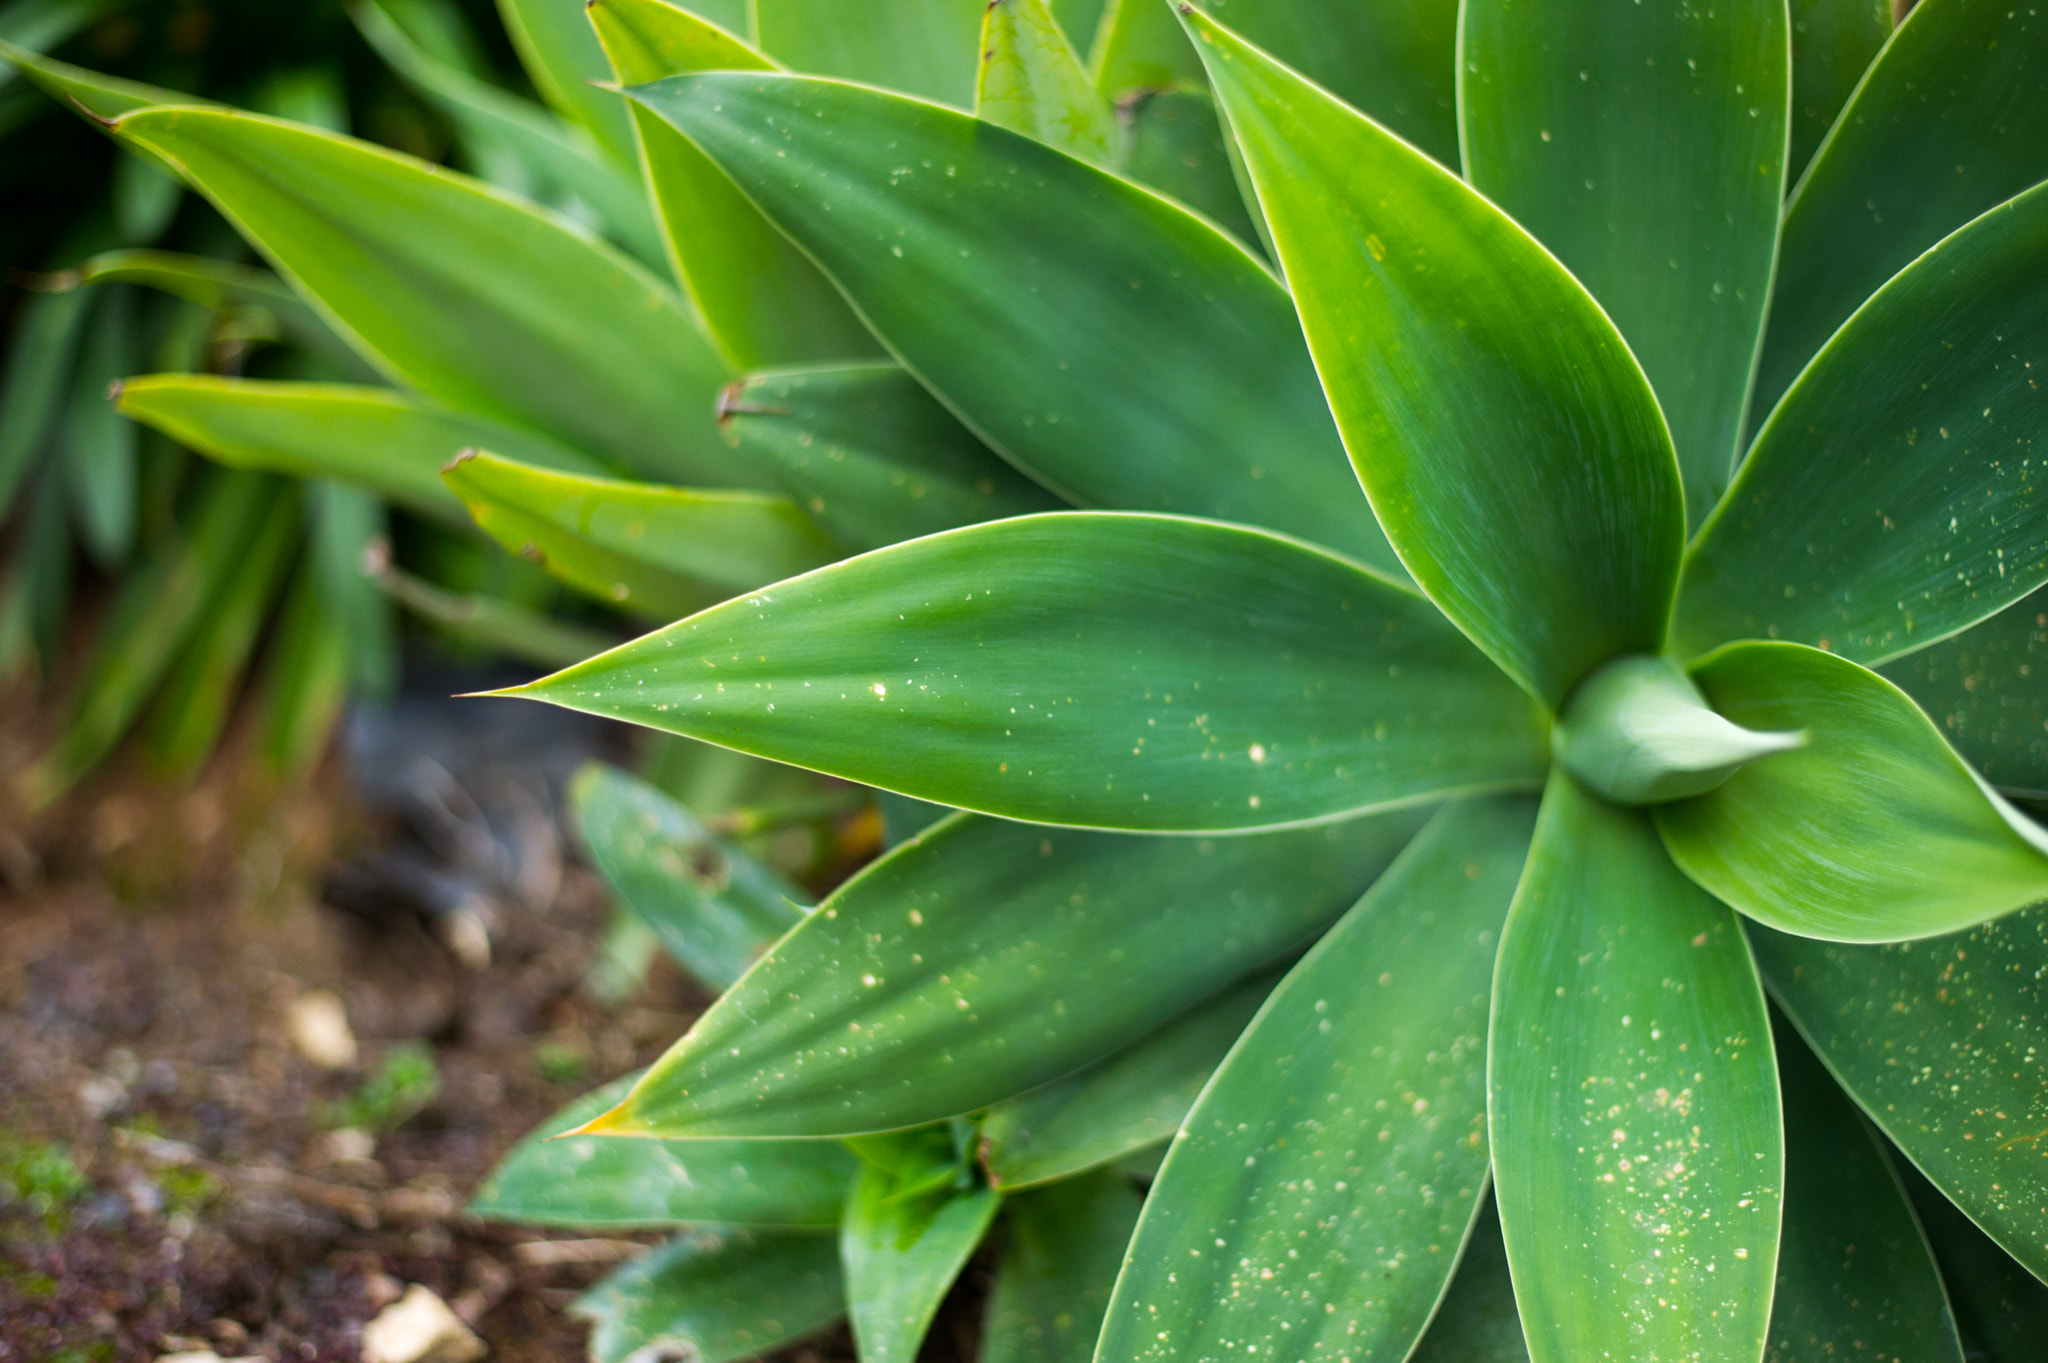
[[975, 0, 1122, 166]]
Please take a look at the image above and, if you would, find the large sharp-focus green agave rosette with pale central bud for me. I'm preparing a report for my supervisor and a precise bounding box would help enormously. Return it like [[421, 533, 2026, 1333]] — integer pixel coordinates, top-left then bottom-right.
[[483, 0, 2048, 1363]]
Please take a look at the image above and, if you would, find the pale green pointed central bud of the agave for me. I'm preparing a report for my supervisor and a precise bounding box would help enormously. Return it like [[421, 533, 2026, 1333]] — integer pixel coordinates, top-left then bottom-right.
[[1550, 653, 1806, 804]]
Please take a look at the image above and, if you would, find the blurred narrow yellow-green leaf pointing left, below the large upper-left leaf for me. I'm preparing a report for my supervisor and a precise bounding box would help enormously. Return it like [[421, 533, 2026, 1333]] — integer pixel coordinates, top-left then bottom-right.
[[117, 375, 598, 524]]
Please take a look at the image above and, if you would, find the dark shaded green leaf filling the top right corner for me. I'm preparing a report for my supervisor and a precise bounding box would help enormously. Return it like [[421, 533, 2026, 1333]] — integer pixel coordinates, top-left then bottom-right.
[[1751, 0, 2048, 424]]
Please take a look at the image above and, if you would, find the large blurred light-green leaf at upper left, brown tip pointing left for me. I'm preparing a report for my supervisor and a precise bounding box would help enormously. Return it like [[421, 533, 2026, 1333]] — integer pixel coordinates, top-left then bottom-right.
[[103, 108, 748, 483]]
